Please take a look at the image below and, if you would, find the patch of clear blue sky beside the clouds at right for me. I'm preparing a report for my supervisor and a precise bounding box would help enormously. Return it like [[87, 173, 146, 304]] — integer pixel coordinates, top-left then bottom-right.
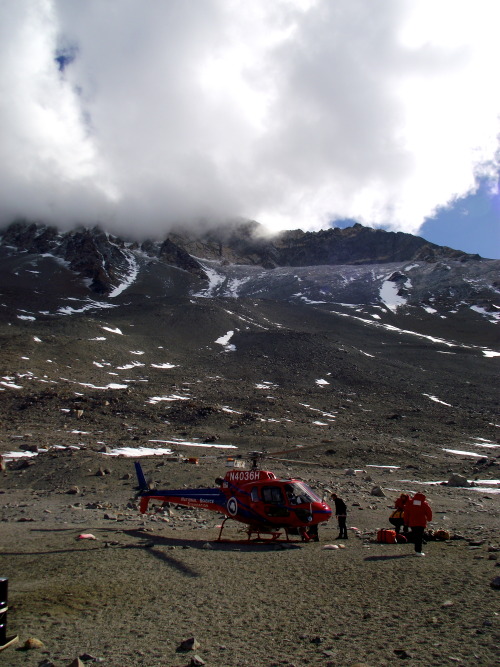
[[419, 180, 500, 259]]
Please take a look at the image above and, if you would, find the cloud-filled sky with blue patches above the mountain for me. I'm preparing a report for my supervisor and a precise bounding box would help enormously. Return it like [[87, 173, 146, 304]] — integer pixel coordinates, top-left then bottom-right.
[[0, 0, 500, 258]]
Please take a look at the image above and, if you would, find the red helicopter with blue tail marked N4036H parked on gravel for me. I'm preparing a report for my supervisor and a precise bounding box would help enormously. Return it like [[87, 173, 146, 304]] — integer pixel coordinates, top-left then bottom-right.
[[135, 452, 332, 541]]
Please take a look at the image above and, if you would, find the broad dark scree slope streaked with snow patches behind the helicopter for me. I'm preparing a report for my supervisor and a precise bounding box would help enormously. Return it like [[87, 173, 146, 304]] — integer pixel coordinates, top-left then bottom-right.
[[0, 222, 500, 478]]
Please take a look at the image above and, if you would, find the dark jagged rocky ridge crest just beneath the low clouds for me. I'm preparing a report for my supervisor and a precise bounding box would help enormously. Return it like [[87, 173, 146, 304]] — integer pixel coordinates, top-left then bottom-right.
[[1, 221, 482, 293]]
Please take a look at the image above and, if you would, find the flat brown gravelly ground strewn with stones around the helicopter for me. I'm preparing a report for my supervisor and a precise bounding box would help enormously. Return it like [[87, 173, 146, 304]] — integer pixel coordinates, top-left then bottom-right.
[[0, 449, 500, 667]]
